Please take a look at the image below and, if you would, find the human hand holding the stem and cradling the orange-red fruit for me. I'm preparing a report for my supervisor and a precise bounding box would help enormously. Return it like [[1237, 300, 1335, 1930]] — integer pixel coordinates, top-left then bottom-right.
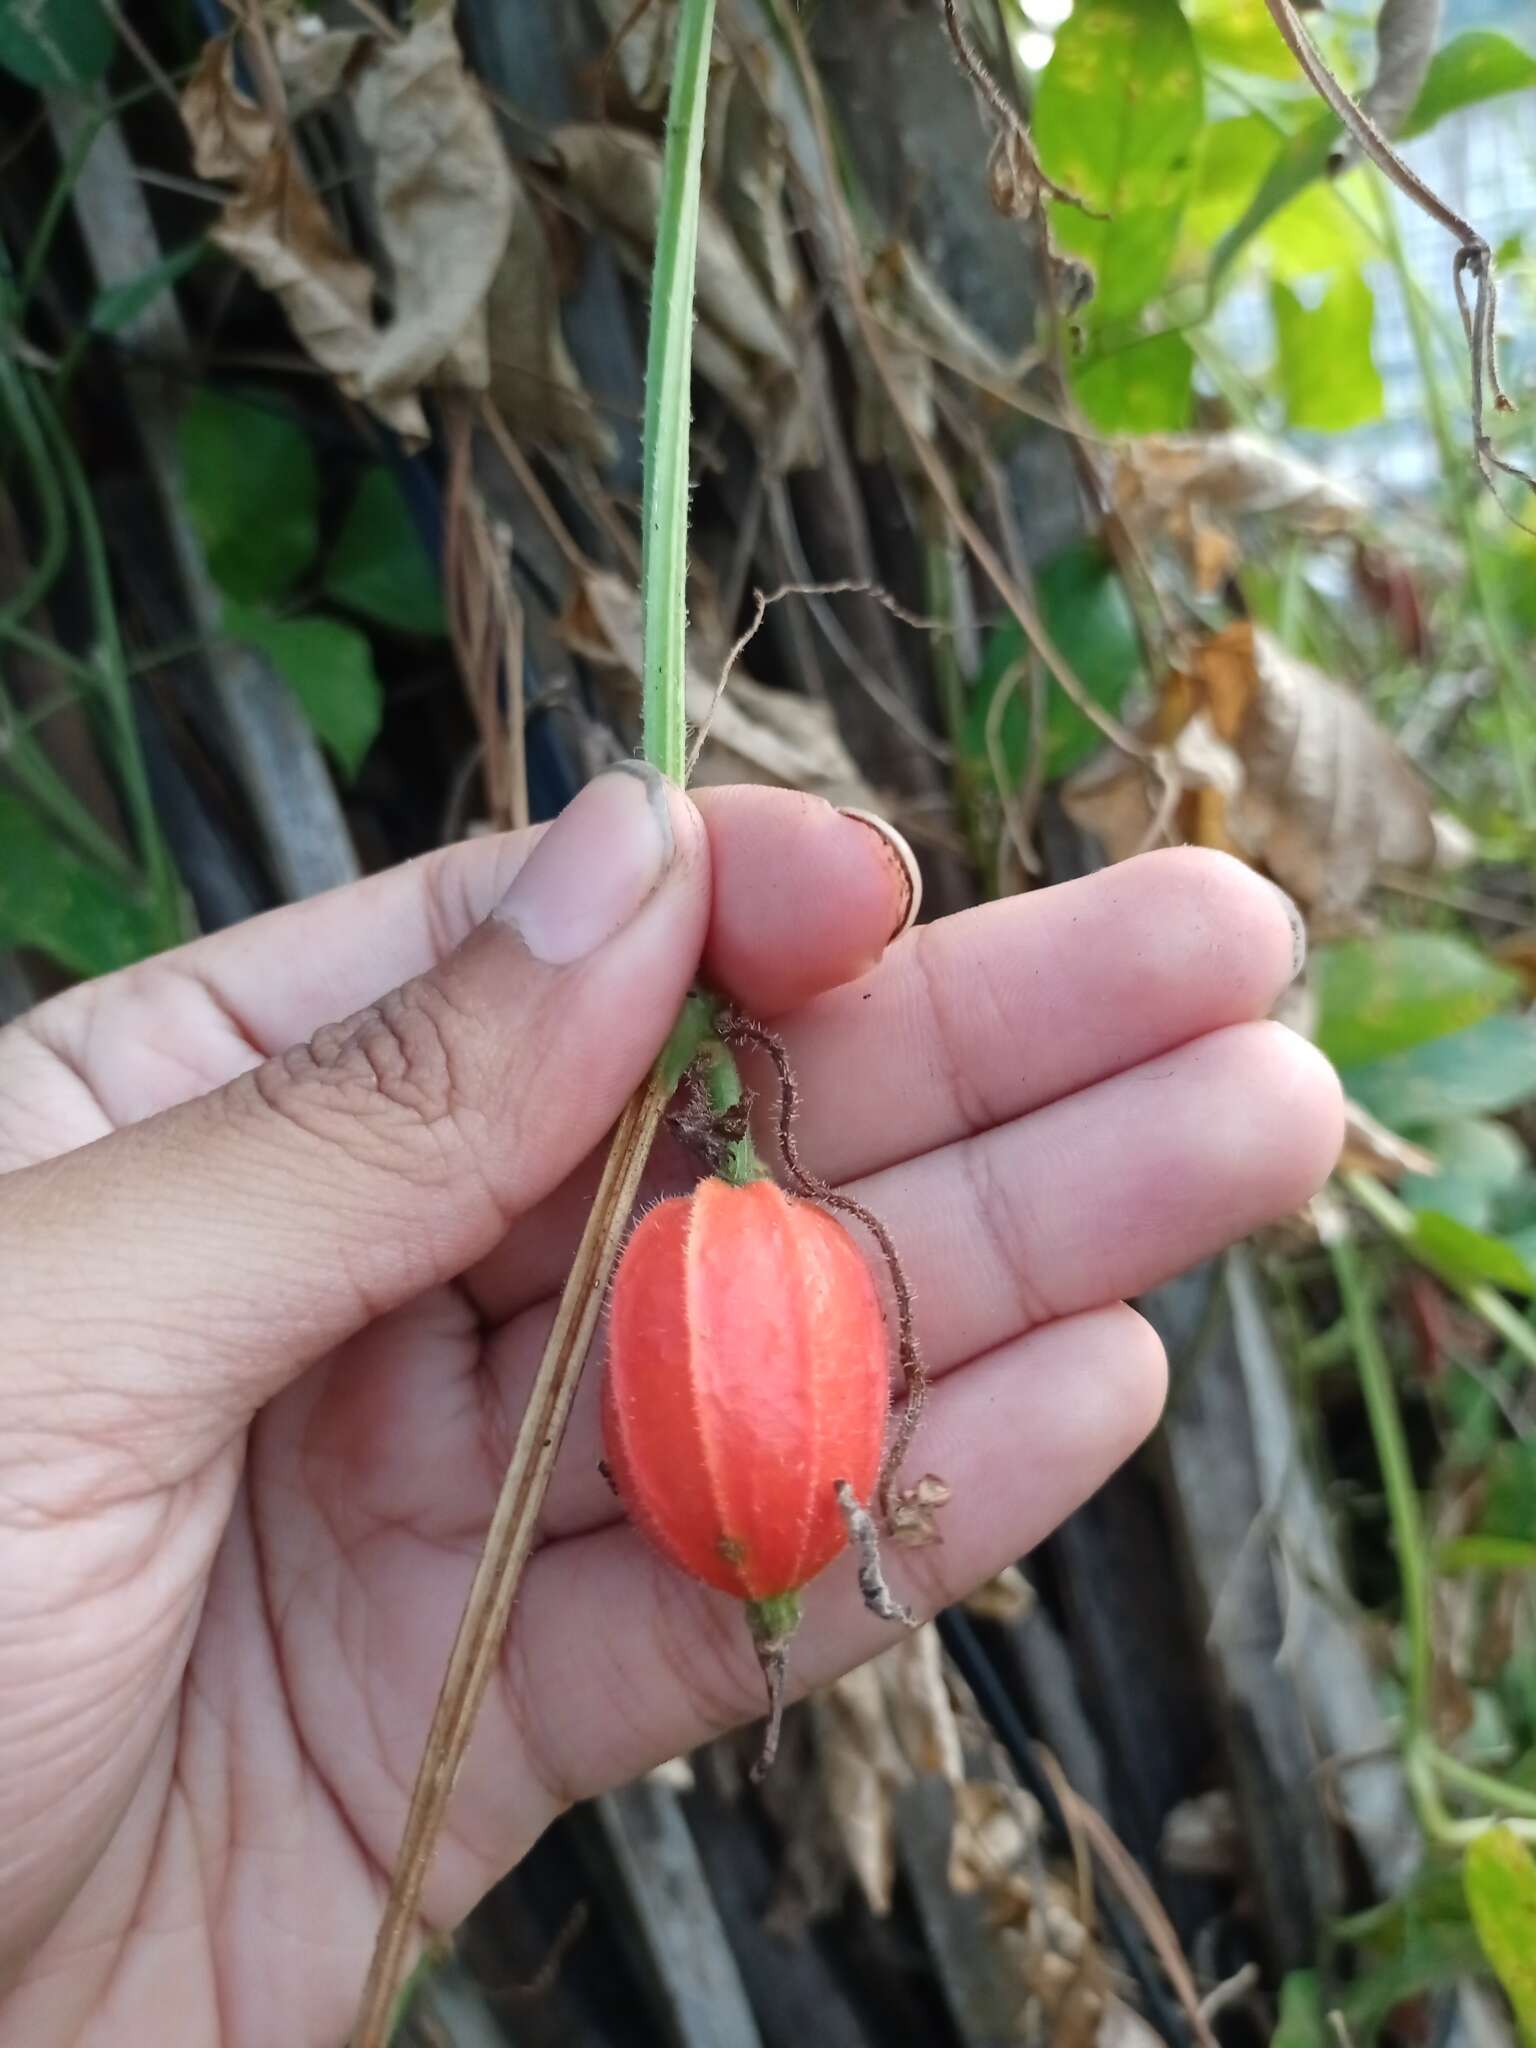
[[0, 772, 1339, 2048]]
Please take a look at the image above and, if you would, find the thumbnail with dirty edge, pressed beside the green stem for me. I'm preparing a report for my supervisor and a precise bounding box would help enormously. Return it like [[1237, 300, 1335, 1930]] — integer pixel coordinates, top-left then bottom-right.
[[496, 762, 676, 967]]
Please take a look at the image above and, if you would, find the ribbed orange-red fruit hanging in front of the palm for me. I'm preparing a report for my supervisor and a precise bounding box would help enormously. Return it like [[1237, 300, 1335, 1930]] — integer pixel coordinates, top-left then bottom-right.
[[602, 1180, 889, 1602]]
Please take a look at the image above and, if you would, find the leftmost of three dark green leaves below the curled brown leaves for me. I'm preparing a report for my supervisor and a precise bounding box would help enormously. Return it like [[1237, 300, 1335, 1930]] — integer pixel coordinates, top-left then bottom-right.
[[180, 389, 319, 604]]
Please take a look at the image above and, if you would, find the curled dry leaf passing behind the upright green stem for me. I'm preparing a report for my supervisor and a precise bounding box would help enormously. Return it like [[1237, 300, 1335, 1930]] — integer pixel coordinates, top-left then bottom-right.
[[551, 123, 817, 469]]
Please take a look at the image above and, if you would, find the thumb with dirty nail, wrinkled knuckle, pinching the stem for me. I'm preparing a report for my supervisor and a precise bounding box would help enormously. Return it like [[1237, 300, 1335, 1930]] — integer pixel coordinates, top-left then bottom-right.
[[0, 764, 709, 1477]]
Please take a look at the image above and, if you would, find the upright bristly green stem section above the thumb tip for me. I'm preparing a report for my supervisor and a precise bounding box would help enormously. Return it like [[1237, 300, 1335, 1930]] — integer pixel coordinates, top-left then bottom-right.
[[641, 0, 715, 784]]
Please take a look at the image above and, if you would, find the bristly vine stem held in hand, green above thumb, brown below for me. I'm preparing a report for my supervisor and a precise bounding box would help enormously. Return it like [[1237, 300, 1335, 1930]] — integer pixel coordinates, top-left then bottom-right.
[[352, 0, 715, 2048]]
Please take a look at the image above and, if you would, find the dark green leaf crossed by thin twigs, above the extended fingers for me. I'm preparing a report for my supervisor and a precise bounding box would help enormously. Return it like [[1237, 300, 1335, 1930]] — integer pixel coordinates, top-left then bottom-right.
[[965, 541, 1141, 788]]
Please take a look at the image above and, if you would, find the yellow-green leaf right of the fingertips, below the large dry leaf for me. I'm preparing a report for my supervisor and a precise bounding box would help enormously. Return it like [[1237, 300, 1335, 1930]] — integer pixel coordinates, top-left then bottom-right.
[[1313, 932, 1520, 1067]]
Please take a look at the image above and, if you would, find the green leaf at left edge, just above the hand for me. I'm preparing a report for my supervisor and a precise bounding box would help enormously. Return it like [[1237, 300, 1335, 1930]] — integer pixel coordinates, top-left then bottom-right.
[[0, 795, 166, 975]]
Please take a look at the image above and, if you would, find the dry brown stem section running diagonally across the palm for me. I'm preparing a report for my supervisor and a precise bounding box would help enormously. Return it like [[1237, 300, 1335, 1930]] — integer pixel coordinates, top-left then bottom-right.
[[352, 1077, 666, 2048]]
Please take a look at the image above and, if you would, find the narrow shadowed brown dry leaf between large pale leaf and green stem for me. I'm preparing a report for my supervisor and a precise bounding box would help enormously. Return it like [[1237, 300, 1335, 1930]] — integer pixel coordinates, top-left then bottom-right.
[[485, 180, 614, 465]]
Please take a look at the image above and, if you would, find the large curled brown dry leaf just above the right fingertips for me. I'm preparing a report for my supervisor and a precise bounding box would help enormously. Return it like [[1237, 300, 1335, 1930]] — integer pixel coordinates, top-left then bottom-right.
[[1065, 621, 1460, 928]]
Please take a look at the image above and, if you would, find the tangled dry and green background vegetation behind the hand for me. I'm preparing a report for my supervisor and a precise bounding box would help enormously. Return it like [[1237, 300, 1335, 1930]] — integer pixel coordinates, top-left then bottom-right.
[[0, 0, 1536, 2048]]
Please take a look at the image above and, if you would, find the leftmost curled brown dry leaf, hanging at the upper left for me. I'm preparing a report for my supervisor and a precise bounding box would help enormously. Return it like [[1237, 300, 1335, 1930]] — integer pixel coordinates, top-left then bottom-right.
[[180, 35, 426, 440]]
